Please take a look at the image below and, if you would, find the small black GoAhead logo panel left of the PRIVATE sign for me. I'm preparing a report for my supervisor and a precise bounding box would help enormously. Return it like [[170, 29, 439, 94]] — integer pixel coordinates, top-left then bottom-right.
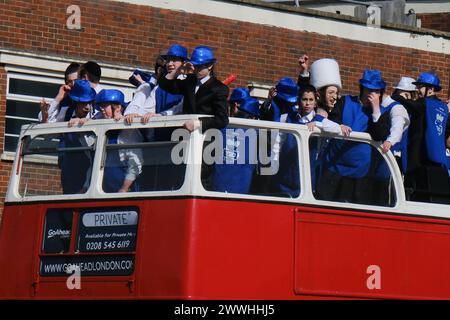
[[42, 209, 73, 253]]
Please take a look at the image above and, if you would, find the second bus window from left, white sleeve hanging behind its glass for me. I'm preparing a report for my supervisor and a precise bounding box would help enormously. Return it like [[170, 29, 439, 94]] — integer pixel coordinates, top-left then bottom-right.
[[102, 128, 189, 193]]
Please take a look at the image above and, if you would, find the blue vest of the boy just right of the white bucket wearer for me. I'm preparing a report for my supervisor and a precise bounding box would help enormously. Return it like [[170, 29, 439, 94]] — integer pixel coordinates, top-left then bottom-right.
[[324, 96, 371, 178]]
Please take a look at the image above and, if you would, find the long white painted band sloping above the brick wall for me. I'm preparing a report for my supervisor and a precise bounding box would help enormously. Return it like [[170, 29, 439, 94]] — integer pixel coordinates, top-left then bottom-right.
[[117, 0, 450, 54]]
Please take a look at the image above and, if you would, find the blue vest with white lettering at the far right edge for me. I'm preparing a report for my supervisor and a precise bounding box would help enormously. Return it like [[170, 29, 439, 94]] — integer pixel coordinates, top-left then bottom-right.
[[425, 98, 448, 167]]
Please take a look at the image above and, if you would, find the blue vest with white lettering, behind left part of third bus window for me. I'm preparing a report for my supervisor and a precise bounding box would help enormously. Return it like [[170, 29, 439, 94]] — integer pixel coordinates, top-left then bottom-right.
[[212, 128, 257, 194]]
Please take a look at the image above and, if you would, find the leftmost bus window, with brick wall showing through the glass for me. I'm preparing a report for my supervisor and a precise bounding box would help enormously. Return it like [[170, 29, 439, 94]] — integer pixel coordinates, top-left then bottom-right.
[[19, 132, 96, 197]]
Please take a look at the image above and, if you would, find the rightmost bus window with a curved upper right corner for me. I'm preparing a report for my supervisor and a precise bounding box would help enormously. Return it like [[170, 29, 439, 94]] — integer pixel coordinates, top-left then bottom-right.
[[309, 136, 396, 207]]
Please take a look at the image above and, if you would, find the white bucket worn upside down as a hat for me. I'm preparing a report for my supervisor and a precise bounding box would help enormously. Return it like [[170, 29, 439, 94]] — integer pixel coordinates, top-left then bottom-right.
[[310, 59, 342, 90]]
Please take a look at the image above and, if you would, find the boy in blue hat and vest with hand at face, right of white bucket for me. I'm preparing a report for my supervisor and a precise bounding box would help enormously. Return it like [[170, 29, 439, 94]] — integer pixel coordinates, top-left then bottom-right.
[[316, 70, 386, 204]]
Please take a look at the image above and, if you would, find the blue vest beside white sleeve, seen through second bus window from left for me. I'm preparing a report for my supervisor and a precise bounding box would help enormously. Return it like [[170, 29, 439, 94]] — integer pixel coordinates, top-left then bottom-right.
[[103, 131, 139, 193]]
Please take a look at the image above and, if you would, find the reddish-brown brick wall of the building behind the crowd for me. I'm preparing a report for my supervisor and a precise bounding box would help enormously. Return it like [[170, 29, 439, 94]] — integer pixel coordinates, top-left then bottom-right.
[[0, 0, 450, 220]]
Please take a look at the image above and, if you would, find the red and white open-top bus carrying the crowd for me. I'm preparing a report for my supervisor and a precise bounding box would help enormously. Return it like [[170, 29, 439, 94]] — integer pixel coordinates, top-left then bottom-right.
[[0, 116, 450, 299]]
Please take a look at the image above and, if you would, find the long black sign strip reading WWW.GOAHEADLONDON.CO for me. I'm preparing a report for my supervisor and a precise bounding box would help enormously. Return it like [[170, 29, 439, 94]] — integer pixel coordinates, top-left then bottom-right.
[[39, 255, 134, 277]]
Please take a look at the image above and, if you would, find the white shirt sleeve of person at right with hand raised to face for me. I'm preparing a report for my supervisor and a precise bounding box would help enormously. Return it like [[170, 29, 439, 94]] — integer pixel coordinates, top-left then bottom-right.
[[372, 97, 410, 145]]
